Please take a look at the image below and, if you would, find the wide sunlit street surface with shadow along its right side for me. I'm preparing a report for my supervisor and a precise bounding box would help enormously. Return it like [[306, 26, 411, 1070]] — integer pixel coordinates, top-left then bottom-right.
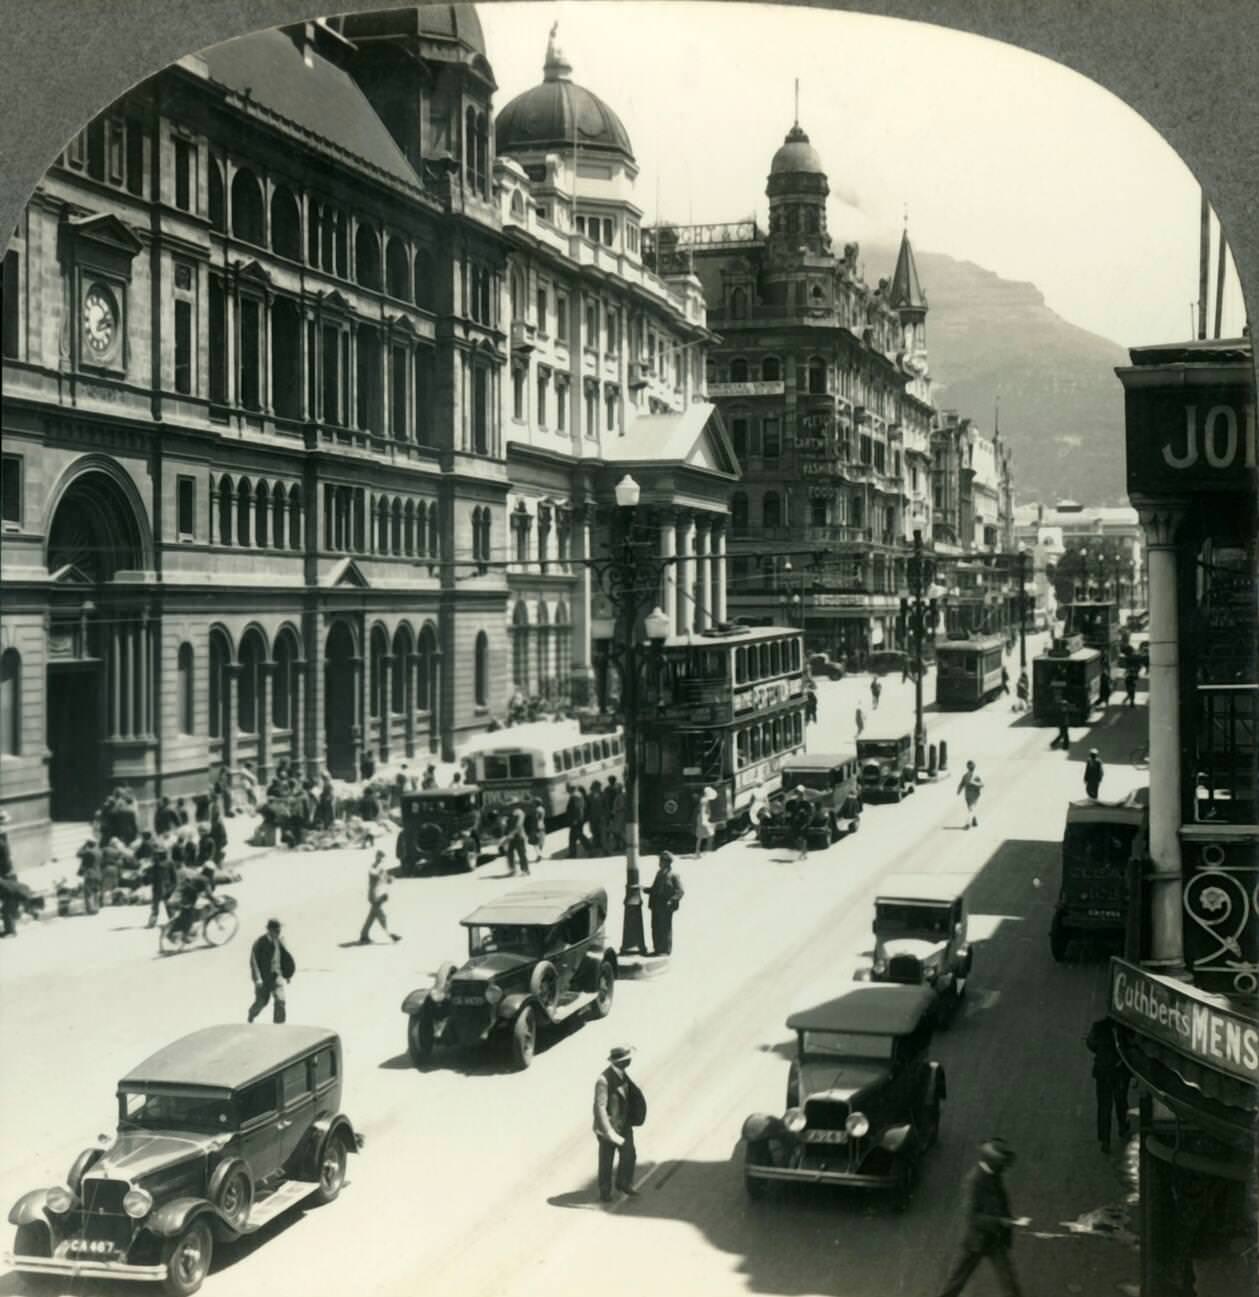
[[0, 648, 1145, 1297]]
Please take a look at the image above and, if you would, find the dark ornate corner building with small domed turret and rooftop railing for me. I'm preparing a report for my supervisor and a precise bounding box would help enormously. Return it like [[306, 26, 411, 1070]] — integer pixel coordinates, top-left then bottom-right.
[[658, 123, 932, 655]]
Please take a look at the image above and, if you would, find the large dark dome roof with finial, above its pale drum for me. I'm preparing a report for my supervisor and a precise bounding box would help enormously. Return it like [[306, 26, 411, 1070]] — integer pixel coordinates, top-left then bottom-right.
[[492, 24, 634, 162]]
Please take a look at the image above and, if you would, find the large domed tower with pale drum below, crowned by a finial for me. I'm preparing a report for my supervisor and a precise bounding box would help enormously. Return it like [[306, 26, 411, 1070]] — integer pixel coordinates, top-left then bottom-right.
[[494, 25, 642, 246]]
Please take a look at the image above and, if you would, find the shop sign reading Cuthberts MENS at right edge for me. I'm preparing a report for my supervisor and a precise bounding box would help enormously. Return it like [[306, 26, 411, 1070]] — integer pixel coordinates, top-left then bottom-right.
[[1110, 958, 1259, 1082]]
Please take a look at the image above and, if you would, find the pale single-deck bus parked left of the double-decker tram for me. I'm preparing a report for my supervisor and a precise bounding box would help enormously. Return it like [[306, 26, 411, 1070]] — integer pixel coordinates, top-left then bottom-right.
[[460, 721, 625, 827]]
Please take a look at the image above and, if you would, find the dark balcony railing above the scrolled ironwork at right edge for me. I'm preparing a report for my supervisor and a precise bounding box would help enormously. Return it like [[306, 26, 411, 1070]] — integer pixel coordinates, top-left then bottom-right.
[[1194, 685, 1259, 824]]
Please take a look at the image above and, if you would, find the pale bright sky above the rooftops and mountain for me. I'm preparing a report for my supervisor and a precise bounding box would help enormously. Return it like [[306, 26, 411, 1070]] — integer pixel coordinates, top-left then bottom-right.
[[478, 0, 1243, 346]]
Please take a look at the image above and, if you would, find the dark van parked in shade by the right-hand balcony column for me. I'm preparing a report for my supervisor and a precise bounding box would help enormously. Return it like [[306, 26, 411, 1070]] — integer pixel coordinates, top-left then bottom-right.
[[1049, 787, 1150, 962]]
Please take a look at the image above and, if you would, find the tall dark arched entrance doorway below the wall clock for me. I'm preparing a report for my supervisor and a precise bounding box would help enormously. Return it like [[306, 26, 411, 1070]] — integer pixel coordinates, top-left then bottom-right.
[[45, 471, 147, 820]]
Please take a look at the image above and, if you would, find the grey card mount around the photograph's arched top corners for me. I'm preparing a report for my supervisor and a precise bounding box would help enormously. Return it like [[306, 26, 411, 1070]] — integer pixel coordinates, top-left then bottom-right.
[[0, 0, 1259, 383]]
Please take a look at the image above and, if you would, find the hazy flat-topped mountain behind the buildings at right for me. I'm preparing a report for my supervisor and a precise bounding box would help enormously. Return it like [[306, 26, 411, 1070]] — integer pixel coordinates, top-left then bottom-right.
[[862, 245, 1128, 505]]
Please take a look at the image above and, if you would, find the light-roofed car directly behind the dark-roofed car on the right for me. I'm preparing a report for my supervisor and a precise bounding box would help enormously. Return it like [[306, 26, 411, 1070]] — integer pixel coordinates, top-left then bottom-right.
[[870, 874, 974, 1026]]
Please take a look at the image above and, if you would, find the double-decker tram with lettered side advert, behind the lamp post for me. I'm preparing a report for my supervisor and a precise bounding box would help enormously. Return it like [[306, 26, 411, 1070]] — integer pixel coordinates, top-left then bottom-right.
[[639, 626, 805, 839]]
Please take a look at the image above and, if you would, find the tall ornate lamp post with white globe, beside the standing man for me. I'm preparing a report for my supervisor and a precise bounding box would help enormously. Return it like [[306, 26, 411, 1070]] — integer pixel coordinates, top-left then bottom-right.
[[590, 473, 676, 955]]
